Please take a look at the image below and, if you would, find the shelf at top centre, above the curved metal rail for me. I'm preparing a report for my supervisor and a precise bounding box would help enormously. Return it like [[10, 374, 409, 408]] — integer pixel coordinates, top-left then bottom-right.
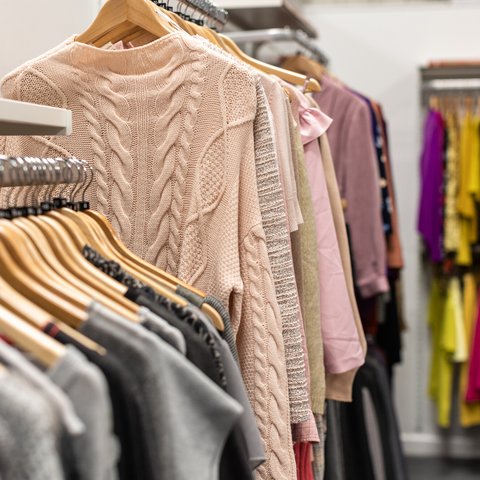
[[216, 0, 318, 38]]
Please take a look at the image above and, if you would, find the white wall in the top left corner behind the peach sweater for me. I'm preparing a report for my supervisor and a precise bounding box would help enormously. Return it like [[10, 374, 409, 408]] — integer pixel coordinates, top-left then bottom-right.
[[0, 0, 99, 78]]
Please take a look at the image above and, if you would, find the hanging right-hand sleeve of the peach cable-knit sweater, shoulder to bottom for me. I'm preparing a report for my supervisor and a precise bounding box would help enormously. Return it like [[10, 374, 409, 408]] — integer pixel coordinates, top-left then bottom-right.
[[220, 68, 296, 480]]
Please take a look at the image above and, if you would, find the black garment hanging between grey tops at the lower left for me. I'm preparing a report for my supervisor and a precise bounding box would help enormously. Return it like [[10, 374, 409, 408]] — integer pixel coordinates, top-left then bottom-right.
[[44, 323, 146, 480]]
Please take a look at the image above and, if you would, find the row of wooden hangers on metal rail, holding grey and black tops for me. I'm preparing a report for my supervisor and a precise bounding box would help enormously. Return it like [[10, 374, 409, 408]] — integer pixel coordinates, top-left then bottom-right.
[[0, 156, 224, 372]]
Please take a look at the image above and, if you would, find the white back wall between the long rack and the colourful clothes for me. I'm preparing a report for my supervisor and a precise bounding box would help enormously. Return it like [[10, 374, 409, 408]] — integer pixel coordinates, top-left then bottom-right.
[[304, 2, 480, 455]]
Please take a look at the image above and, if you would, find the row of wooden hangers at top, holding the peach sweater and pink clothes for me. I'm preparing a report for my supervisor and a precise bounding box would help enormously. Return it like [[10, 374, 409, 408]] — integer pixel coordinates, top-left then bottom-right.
[[75, 0, 320, 92]]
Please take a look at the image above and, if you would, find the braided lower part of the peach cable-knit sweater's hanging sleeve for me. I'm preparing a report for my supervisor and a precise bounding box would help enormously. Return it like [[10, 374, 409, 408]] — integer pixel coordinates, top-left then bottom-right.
[[242, 226, 296, 480]]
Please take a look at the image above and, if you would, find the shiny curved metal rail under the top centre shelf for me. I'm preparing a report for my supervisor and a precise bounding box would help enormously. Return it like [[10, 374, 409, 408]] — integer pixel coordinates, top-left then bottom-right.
[[228, 27, 328, 65]]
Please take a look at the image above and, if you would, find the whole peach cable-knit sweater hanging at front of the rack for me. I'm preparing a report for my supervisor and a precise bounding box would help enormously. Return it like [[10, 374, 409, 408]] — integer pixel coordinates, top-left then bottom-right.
[[1, 32, 295, 480]]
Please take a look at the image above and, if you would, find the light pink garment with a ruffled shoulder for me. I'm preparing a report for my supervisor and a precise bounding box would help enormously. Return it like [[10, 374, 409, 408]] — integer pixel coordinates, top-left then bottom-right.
[[288, 86, 365, 373]]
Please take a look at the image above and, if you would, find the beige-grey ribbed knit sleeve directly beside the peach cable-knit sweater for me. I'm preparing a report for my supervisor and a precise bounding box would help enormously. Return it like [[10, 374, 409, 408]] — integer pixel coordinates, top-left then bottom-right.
[[254, 82, 310, 423]]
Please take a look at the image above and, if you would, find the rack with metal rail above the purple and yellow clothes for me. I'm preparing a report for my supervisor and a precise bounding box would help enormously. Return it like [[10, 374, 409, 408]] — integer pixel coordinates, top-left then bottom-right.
[[420, 62, 480, 107]]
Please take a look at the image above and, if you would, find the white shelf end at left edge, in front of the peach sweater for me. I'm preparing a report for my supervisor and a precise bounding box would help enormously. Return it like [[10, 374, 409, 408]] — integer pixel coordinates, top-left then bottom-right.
[[0, 98, 72, 135]]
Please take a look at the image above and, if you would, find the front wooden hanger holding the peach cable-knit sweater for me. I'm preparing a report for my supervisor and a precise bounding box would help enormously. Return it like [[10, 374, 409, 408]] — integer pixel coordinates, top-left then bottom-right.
[[75, 0, 178, 46]]
